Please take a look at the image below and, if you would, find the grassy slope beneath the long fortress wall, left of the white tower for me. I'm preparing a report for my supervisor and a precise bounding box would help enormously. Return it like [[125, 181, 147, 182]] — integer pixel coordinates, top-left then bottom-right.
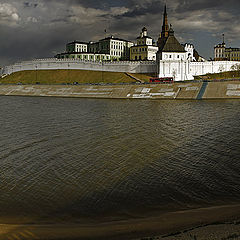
[[0, 70, 151, 84]]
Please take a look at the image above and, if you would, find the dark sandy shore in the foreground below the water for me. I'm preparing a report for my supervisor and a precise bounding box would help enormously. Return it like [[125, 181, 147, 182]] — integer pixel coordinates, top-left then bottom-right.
[[0, 205, 240, 240]]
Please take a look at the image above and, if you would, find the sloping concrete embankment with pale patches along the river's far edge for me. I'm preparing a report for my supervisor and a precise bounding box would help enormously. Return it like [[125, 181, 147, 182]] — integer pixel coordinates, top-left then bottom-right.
[[0, 80, 240, 100]]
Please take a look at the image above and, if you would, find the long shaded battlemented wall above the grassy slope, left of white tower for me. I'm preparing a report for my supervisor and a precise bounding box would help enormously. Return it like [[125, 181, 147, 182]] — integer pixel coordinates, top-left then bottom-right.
[[0, 58, 157, 75]]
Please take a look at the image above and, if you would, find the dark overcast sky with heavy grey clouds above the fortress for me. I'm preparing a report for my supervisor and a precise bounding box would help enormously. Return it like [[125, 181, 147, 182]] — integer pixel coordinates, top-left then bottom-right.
[[0, 0, 240, 66]]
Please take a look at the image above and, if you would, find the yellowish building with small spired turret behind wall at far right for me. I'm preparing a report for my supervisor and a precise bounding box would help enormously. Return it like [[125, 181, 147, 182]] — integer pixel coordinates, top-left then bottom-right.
[[214, 35, 240, 61]]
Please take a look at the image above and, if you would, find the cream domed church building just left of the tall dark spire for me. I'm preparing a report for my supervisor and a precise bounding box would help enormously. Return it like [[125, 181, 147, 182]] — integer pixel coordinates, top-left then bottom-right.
[[130, 27, 158, 61]]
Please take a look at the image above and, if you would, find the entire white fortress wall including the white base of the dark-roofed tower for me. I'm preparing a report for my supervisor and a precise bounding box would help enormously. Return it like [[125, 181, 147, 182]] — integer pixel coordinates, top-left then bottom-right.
[[0, 57, 240, 81]]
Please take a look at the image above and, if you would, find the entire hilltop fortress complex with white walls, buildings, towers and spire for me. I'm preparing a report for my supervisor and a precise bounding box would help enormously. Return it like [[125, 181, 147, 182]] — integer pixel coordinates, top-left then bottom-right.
[[0, 6, 240, 81]]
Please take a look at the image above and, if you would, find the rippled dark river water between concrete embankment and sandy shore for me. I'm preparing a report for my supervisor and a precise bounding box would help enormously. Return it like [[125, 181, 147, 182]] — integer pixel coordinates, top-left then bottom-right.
[[0, 96, 240, 222]]
